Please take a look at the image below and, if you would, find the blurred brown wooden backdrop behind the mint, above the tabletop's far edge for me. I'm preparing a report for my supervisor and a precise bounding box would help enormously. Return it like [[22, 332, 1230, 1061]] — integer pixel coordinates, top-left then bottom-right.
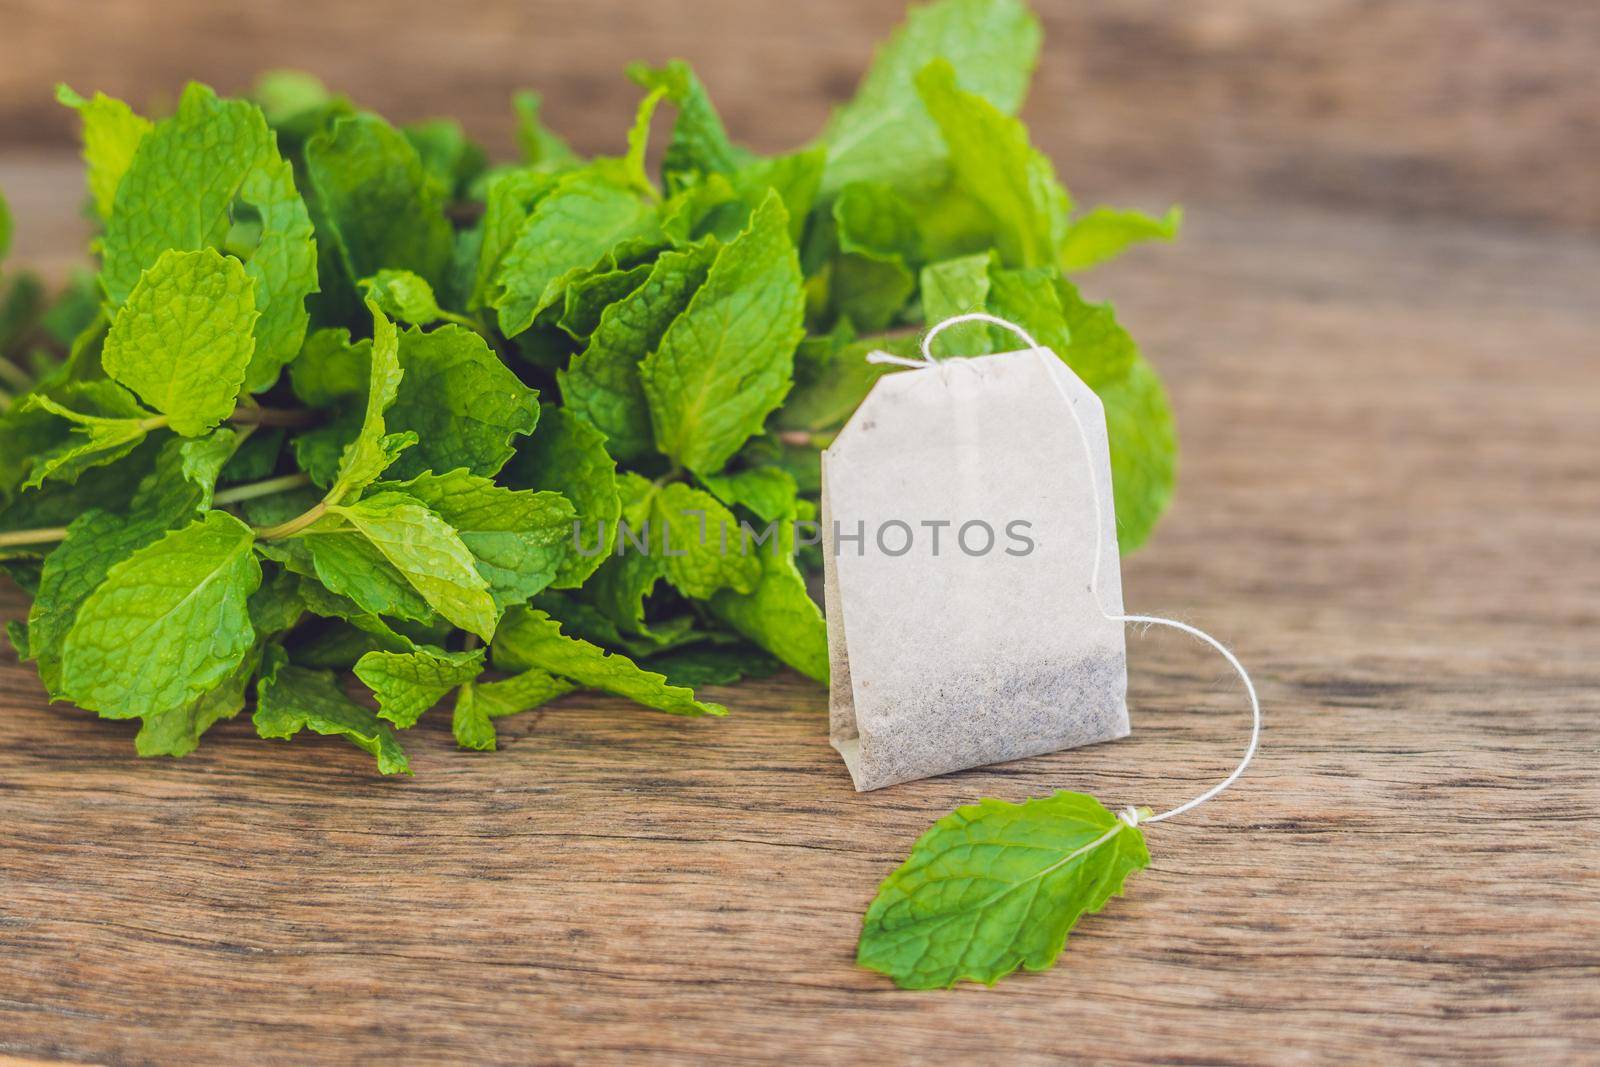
[[0, 0, 1600, 269]]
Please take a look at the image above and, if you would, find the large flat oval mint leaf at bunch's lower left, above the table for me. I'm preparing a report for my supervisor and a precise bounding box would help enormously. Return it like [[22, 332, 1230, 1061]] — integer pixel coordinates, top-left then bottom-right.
[[61, 512, 261, 718]]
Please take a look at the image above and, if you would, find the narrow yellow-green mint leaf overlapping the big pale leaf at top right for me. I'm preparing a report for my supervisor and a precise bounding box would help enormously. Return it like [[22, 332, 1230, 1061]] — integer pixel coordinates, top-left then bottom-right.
[[917, 61, 1072, 267]]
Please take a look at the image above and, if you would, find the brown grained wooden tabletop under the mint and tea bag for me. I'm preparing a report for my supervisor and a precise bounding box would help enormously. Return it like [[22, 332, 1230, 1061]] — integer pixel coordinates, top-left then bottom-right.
[[0, 168, 1600, 1064]]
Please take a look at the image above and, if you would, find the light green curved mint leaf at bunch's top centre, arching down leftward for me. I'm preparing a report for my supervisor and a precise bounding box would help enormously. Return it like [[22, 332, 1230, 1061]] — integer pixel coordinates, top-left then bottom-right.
[[491, 166, 654, 338]]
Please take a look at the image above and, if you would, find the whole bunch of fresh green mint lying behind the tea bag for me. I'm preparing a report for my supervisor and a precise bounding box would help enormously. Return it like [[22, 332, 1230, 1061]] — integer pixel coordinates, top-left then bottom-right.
[[0, 0, 1178, 773]]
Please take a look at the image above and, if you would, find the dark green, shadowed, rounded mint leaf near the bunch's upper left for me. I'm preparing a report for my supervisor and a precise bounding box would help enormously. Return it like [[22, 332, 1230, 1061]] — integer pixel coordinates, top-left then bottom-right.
[[306, 114, 454, 286]]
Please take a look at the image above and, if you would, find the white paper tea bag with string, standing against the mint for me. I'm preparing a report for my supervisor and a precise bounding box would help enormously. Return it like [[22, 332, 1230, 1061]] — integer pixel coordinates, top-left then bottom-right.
[[822, 317, 1128, 790]]
